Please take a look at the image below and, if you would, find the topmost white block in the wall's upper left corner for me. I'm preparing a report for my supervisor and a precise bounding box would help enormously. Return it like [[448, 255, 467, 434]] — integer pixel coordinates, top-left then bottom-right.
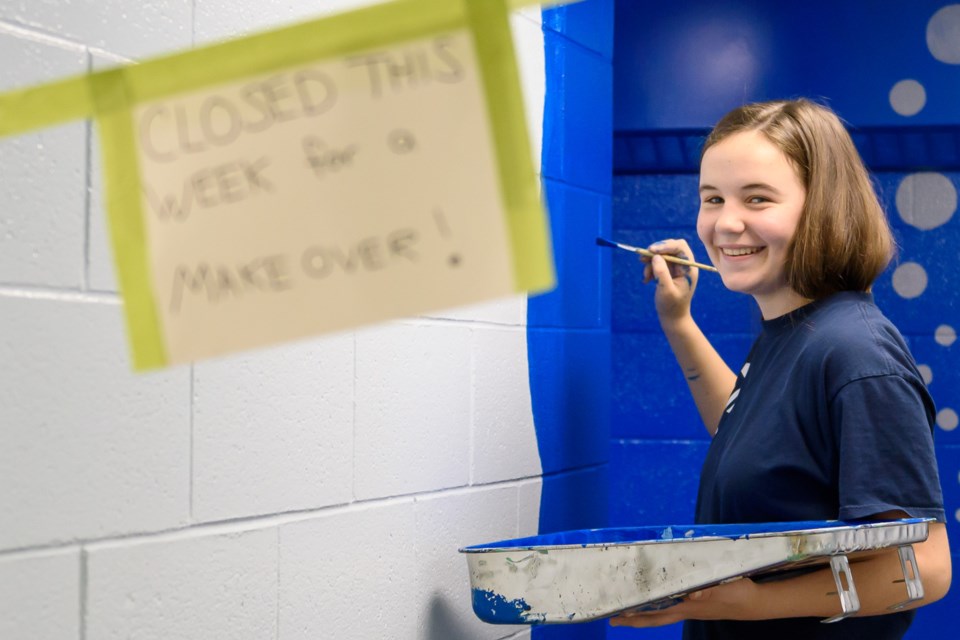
[[0, 0, 193, 58]]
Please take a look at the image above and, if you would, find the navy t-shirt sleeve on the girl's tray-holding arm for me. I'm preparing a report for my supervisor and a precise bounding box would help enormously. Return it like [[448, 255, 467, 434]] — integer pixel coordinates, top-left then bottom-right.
[[830, 374, 946, 522]]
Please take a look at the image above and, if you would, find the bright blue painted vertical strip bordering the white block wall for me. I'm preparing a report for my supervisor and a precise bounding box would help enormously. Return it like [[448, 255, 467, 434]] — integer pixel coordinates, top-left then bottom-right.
[[527, 0, 613, 640]]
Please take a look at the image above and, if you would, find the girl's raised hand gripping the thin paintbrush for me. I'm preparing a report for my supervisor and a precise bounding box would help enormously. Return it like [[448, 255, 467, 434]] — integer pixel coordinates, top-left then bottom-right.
[[640, 239, 700, 328]]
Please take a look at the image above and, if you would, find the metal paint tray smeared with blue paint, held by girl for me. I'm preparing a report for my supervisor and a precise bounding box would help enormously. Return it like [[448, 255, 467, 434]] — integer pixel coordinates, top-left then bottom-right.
[[460, 518, 930, 624]]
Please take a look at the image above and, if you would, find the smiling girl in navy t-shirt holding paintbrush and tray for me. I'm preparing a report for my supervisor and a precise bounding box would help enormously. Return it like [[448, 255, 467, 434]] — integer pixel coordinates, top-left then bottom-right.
[[612, 100, 951, 640]]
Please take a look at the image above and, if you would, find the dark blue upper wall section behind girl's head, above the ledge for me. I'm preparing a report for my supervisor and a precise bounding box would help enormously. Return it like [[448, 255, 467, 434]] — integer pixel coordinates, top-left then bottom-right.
[[614, 0, 960, 131]]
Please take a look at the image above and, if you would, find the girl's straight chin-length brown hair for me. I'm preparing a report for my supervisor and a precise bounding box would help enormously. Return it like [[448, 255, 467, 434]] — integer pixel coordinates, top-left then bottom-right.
[[701, 100, 895, 299]]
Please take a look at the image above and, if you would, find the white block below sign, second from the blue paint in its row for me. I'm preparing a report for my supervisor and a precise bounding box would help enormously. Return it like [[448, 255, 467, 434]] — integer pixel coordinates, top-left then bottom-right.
[[354, 323, 472, 500]]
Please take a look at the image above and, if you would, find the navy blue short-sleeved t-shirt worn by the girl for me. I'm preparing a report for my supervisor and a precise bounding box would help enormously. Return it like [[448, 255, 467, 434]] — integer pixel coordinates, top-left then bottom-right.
[[683, 292, 945, 640]]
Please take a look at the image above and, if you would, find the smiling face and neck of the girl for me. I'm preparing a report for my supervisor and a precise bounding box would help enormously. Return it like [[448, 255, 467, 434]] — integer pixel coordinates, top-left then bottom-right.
[[697, 131, 807, 320]]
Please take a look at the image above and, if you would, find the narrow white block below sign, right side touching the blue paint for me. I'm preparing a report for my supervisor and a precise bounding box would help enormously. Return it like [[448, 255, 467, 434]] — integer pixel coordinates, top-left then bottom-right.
[[471, 327, 541, 484]]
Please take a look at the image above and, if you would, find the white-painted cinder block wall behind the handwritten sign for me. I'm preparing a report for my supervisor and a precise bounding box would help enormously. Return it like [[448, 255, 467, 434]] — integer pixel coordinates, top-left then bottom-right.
[[0, 0, 545, 640]]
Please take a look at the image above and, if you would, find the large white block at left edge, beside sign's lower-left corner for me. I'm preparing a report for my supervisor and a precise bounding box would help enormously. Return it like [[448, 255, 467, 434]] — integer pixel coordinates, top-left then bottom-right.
[[0, 296, 190, 549]]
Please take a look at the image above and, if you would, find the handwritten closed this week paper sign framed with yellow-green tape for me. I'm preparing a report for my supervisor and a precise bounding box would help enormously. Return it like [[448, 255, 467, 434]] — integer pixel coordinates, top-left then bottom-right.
[[0, 0, 552, 368]]
